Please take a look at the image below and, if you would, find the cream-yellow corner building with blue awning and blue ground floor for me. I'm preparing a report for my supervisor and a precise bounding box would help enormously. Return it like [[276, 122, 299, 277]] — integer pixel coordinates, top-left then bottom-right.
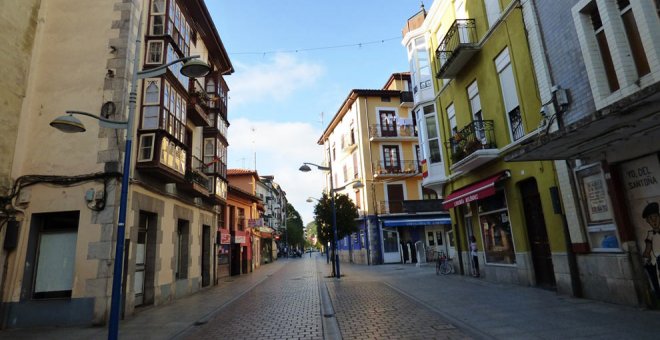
[[318, 73, 453, 264]]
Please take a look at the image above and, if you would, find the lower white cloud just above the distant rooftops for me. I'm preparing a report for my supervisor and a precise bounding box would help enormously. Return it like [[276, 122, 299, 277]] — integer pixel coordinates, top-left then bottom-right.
[[228, 118, 324, 224]]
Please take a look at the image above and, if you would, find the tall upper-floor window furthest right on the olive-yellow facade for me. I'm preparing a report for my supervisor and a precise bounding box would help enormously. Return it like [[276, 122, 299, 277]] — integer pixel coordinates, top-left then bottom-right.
[[495, 48, 525, 141]]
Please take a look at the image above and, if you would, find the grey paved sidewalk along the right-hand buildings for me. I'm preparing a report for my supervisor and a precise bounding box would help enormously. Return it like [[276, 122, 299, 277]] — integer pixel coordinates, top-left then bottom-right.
[[340, 263, 660, 339]]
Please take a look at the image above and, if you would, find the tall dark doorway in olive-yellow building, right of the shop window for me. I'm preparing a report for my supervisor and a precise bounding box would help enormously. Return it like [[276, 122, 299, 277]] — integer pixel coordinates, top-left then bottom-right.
[[520, 178, 556, 289]]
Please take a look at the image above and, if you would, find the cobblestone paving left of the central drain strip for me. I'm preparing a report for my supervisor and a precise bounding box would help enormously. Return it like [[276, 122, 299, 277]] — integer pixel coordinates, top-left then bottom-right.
[[182, 258, 323, 340]]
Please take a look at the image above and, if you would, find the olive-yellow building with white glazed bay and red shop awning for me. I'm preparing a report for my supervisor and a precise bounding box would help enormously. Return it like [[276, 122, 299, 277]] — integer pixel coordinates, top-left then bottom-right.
[[403, 0, 570, 292]]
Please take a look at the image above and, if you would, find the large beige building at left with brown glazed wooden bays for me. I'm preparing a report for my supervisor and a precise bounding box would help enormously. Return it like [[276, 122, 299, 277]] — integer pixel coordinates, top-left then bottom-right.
[[0, 0, 233, 327]]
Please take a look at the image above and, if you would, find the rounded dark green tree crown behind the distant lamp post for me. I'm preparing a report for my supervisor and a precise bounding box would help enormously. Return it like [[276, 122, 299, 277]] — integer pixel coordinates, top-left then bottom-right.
[[314, 193, 358, 244]]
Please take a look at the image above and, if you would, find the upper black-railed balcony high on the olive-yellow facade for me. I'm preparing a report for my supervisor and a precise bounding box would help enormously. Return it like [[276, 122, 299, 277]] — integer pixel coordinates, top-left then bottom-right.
[[435, 19, 481, 79]]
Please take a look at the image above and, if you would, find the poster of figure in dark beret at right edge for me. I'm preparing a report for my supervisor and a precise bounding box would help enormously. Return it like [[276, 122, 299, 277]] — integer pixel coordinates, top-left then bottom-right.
[[620, 154, 660, 298]]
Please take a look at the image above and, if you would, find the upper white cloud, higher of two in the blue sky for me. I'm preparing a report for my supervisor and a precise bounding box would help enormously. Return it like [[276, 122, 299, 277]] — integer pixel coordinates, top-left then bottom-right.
[[227, 54, 324, 107]]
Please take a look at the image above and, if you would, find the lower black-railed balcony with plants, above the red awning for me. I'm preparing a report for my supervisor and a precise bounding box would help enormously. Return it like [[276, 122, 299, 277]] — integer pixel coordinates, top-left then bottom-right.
[[446, 120, 499, 172]]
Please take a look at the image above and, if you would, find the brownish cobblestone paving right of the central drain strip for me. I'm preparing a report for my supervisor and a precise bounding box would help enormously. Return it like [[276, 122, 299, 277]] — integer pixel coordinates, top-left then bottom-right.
[[327, 280, 470, 339]]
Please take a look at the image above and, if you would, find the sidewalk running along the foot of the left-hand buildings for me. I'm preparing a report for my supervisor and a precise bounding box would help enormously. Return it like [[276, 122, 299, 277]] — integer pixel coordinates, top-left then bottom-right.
[[0, 259, 292, 339]]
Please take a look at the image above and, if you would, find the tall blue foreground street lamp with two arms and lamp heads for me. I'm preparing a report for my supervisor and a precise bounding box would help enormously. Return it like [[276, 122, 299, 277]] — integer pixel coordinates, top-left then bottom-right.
[[50, 35, 211, 340]]
